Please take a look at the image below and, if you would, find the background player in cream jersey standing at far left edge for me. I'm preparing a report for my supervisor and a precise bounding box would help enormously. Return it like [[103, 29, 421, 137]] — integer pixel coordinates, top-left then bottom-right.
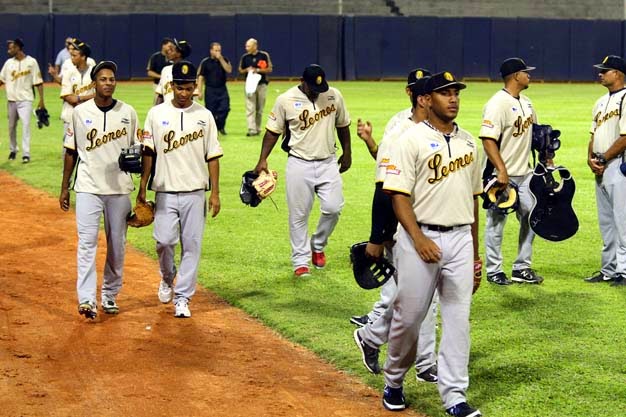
[[0, 38, 45, 163]]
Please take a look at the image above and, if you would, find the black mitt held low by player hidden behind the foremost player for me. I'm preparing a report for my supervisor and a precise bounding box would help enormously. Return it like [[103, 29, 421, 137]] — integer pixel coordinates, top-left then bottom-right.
[[350, 242, 396, 290]]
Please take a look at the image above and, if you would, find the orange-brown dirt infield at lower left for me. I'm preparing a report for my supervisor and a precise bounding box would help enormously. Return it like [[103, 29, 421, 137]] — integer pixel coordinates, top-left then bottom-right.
[[0, 171, 415, 417]]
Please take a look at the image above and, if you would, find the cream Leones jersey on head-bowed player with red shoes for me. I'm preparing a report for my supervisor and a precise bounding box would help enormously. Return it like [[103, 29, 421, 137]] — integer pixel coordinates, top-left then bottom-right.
[[265, 86, 350, 161]]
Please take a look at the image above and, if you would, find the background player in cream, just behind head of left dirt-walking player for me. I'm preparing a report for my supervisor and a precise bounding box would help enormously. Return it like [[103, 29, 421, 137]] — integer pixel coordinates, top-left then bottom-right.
[[61, 39, 95, 150]]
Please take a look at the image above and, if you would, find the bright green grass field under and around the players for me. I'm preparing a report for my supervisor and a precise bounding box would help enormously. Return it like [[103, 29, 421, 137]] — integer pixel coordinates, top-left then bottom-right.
[[0, 81, 626, 417]]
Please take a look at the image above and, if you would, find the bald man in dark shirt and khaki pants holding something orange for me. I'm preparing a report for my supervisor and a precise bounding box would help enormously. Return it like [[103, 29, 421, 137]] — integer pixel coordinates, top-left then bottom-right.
[[239, 38, 272, 136]]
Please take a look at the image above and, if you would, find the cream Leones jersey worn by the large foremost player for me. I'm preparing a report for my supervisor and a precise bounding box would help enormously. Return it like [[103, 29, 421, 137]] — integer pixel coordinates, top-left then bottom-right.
[[383, 122, 482, 226]]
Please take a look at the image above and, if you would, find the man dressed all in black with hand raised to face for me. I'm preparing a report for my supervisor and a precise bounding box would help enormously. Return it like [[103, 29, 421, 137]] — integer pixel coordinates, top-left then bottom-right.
[[197, 42, 233, 135]]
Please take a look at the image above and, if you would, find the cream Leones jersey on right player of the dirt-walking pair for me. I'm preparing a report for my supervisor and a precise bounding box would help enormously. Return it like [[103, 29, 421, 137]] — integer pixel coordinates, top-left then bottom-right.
[[143, 101, 223, 192]]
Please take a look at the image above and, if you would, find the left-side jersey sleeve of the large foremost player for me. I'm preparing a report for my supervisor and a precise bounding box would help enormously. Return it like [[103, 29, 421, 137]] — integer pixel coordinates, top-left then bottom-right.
[[383, 131, 418, 196]]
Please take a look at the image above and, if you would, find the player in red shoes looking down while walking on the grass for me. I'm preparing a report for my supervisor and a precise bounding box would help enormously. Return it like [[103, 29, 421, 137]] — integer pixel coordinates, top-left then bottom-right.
[[254, 65, 352, 277]]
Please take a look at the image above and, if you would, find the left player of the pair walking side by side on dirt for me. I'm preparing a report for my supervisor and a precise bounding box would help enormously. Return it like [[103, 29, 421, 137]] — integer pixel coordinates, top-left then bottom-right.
[[59, 61, 138, 319]]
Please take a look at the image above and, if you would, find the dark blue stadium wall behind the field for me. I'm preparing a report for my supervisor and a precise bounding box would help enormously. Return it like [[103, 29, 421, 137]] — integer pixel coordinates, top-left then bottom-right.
[[0, 14, 626, 81]]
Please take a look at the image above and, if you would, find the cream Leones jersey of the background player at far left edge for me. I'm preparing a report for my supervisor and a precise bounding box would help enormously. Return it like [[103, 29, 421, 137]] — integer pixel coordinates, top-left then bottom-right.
[[0, 55, 43, 101]]
